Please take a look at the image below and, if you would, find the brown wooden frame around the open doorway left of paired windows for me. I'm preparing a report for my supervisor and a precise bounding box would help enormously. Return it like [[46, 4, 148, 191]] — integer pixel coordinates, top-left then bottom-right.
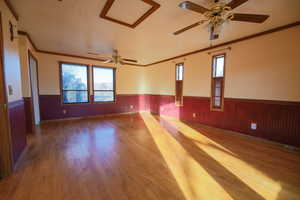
[[28, 49, 41, 128]]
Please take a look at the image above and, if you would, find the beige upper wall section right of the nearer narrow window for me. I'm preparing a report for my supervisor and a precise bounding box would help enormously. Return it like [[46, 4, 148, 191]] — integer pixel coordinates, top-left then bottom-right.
[[225, 26, 300, 101]]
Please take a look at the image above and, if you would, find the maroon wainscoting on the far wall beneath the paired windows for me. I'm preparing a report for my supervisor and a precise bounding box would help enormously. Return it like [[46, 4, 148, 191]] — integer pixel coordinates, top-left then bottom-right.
[[40, 94, 145, 120]]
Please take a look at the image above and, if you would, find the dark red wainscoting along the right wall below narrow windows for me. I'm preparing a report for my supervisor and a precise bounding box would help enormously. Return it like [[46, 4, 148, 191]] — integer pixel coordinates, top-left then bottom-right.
[[145, 95, 300, 147]]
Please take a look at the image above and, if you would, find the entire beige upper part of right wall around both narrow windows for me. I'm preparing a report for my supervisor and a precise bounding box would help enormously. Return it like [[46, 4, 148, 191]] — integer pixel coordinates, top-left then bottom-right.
[[144, 26, 300, 101]]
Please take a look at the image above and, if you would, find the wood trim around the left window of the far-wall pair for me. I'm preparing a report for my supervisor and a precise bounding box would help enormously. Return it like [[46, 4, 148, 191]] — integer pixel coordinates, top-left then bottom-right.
[[58, 61, 91, 106]]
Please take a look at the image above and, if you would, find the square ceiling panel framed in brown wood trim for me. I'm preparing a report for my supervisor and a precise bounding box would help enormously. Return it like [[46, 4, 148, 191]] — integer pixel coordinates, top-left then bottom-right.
[[100, 0, 160, 28]]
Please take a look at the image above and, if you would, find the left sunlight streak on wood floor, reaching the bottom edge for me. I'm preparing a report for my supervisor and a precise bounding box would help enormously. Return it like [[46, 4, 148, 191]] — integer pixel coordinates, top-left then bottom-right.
[[141, 113, 233, 200]]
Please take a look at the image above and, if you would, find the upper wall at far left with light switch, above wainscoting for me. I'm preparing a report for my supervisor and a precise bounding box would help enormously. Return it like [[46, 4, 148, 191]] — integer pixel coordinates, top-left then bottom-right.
[[0, 0, 22, 102]]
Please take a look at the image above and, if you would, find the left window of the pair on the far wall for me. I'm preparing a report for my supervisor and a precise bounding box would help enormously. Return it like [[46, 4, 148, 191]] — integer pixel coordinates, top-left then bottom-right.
[[60, 63, 89, 104]]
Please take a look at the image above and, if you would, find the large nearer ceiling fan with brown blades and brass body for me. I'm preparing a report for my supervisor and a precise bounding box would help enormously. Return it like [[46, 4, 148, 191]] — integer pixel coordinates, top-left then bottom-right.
[[174, 0, 269, 40]]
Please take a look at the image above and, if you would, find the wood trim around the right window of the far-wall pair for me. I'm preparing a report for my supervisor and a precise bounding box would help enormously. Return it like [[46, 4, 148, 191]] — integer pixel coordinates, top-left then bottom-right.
[[92, 65, 117, 104]]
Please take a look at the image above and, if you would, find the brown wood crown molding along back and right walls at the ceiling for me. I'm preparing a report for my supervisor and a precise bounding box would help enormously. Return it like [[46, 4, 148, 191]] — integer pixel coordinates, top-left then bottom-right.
[[18, 21, 300, 67]]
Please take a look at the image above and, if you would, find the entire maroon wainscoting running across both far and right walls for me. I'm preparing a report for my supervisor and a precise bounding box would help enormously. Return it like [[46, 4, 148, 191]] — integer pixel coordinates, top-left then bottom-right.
[[40, 95, 300, 147]]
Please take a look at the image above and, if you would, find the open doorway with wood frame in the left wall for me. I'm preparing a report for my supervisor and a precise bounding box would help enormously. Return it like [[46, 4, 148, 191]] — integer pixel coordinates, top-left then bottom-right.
[[28, 50, 41, 126]]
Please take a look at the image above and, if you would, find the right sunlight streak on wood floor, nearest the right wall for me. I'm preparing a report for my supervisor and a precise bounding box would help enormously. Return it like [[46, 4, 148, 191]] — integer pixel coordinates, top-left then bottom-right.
[[161, 117, 282, 200]]
